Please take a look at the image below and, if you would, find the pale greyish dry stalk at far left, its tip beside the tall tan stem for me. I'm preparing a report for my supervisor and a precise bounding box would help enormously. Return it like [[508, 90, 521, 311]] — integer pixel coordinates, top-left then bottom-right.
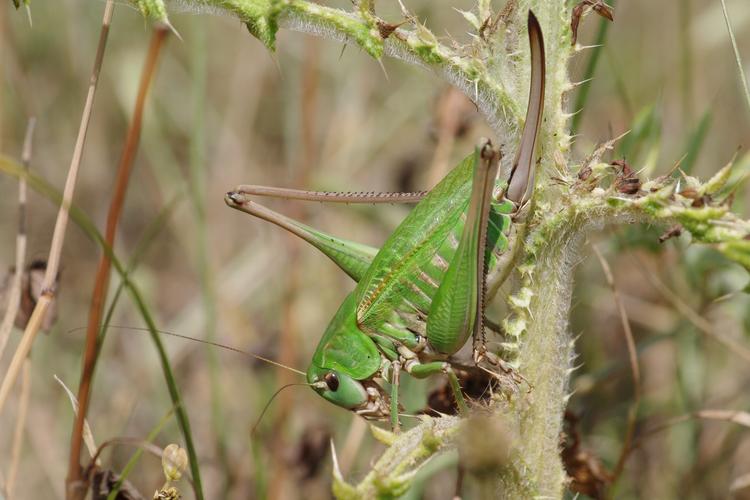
[[0, 118, 35, 359]]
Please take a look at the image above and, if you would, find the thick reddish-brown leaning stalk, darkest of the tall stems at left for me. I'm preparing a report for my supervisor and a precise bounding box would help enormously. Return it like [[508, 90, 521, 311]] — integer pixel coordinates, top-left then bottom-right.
[[66, 26, 169, 498]]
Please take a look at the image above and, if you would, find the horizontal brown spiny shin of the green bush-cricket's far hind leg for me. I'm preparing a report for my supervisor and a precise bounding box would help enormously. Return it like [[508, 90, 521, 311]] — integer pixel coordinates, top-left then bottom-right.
[[230, 184, 428, 203]]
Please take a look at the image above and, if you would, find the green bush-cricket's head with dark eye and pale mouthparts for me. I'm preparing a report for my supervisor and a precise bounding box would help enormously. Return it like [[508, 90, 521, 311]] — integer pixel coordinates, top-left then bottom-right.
[[307, 363, 390, 419]]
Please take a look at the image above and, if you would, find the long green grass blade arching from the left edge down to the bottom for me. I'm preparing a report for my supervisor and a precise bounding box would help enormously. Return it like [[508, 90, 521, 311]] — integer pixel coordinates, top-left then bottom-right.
[[0, 157, 204, 500]]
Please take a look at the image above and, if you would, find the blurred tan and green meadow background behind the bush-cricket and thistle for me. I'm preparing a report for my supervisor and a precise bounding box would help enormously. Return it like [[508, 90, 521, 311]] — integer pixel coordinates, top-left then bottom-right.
[[0, 0, 750, 498]]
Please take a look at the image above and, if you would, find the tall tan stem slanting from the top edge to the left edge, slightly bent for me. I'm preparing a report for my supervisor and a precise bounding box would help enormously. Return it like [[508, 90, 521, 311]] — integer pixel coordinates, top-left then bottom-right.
[[0, 0, 114, 413]]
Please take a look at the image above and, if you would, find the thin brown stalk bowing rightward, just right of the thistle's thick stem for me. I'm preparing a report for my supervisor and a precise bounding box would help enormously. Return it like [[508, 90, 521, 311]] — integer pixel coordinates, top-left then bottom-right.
[[591, 245, 641, 483]]
